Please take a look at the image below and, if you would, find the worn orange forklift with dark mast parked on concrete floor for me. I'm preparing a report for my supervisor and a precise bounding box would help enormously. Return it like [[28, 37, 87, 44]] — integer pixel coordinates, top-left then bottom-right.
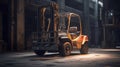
[[32, 2, 88, 56]]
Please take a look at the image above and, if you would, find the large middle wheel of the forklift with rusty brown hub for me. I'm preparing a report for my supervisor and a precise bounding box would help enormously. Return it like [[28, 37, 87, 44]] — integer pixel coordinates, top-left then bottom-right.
[[59, 42, 71, 56]]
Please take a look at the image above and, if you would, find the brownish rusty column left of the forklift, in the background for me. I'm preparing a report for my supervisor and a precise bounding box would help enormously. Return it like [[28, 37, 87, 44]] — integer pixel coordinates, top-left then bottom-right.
[[17, 0, 24, 51]]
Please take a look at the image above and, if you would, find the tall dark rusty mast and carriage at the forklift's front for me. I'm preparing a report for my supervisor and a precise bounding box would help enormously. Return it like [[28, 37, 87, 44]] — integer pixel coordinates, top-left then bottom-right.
[[33, 2, 59, 50]]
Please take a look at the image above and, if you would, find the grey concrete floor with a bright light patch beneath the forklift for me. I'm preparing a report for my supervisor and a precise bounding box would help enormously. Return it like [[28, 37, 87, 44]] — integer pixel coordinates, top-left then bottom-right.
[[0, 48, 120, 67]]
